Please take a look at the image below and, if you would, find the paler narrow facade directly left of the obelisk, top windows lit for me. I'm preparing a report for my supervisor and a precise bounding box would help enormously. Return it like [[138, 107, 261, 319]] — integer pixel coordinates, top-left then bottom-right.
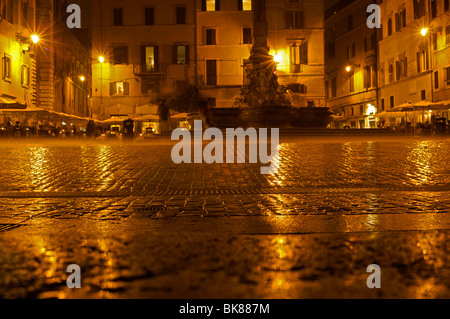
[[196, 0, 253, 107]]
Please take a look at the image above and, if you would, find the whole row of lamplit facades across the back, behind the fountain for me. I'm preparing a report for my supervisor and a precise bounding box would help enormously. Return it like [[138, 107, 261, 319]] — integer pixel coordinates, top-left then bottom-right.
[[92, 0, 325, 119]]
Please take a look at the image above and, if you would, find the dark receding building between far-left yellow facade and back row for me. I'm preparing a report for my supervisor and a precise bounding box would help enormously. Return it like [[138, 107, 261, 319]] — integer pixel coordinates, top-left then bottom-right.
[[36, 0, 91, 117]]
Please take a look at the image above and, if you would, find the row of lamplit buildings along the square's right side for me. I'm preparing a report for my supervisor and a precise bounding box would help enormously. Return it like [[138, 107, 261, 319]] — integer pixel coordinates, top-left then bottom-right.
[[325, 0, 450, 129]]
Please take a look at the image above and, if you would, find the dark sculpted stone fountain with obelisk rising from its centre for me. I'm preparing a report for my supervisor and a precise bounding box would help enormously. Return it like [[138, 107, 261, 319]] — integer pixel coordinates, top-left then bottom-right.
[[235, 0, 331, 127]]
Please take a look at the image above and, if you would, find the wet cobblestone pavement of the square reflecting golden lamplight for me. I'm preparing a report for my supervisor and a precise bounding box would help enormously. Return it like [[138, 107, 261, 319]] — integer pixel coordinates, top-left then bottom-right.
[[0, 137, 450, 298]]
